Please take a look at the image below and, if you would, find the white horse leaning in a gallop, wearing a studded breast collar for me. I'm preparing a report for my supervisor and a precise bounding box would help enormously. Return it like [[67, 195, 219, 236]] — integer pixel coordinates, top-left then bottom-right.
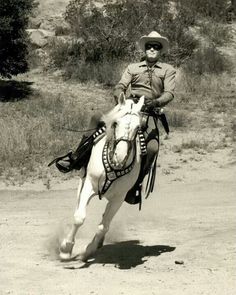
[[60, 95, 144, 261]]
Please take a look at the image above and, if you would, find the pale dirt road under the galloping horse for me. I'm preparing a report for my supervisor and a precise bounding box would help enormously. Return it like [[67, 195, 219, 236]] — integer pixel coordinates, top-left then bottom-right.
[[0, 162, 236, 295]]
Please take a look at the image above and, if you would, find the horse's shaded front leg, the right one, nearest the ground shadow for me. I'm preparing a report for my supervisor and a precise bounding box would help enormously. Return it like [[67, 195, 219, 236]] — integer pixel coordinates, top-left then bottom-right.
[[80, 196, 124, 261]]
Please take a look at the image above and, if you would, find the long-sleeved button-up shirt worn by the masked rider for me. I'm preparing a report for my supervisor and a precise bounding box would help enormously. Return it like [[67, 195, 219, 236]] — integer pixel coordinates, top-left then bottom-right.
[[115, 61, 176, 99]]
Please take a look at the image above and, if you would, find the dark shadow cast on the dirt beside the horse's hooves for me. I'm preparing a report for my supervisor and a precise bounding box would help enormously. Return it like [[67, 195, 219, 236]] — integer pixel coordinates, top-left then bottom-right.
[[74, 240, 175, 269]]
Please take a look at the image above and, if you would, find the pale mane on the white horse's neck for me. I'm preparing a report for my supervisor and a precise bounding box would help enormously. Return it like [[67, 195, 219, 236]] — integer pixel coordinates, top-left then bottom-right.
[[102, 99, 134, 140]]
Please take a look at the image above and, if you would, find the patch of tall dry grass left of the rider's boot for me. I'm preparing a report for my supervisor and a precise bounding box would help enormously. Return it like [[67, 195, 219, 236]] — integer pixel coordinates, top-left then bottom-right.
[[0, 83, 110, 178]]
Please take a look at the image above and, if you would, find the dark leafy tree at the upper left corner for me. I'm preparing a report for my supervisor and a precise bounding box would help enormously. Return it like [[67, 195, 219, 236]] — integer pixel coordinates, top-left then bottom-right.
[[0, 0, 37, 78]]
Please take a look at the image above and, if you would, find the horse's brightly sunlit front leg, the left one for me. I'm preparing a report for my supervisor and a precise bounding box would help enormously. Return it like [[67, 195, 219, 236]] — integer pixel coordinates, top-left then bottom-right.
[[60, 178, 95, 261]]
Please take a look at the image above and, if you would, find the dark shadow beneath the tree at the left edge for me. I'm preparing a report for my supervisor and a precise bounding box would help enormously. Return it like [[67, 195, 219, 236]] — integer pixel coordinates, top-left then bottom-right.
[[0, 79, 33, 102]]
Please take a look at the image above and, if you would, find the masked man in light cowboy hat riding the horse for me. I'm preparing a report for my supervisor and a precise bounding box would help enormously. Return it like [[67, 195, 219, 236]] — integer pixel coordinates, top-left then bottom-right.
[[50, 31, 176, 203]]
